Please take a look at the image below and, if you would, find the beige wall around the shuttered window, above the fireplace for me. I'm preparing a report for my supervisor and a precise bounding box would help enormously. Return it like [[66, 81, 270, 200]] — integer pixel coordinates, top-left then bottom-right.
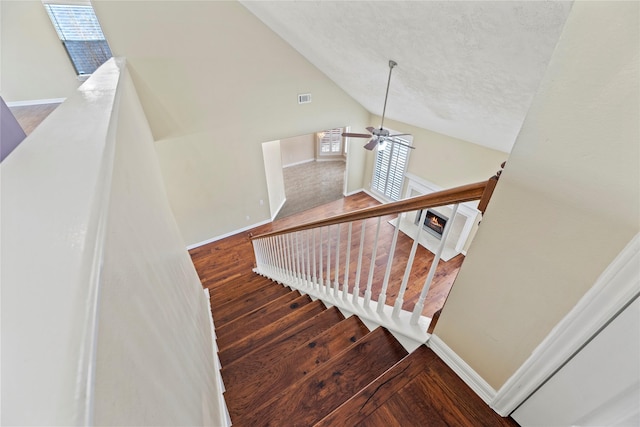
[[362, 116, 508, 193]]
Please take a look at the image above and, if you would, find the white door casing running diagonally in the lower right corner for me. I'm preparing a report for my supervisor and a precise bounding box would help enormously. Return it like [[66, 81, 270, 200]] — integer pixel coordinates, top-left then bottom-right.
[[490, 233, 640, 416]]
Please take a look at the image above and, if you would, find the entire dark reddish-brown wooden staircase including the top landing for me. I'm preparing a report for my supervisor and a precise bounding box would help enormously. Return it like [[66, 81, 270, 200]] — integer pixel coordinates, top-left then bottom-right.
[[209, 274, 516, 427]]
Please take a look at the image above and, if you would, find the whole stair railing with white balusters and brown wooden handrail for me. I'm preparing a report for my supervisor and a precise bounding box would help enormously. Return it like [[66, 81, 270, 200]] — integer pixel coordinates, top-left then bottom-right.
[[252, 169, 499, 343]]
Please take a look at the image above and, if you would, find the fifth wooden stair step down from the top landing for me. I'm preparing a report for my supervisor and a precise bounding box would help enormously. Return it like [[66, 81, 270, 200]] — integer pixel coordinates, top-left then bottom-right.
[[216, 291, 311, 350]]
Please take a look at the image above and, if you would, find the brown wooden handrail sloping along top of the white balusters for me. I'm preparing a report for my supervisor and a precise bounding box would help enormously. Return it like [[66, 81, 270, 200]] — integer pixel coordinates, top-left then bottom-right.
[[251, 181, 489, 240]]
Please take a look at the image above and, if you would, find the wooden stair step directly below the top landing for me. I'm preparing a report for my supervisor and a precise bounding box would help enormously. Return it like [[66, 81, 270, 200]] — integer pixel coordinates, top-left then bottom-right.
[[238, 328, 407, 426]]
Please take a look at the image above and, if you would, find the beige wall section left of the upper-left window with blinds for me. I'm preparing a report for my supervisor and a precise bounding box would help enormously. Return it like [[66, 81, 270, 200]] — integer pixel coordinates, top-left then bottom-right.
[[0, 0, 80, 103]]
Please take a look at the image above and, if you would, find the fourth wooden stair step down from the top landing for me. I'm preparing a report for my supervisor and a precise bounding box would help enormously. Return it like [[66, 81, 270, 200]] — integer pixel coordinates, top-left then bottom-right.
[[218, 300, 326, 366]]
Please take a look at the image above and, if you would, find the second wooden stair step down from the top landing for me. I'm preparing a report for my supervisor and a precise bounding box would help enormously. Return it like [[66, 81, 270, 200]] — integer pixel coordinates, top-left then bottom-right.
[[225, 316, 369, 419]]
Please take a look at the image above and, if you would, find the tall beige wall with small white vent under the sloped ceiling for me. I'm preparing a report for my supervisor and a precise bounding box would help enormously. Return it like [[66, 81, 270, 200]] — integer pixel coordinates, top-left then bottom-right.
[[94, 1, 369, 245]]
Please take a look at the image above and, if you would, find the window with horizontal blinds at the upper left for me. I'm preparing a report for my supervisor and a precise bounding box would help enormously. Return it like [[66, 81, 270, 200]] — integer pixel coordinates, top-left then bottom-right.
[[44, 3, 111, 76]]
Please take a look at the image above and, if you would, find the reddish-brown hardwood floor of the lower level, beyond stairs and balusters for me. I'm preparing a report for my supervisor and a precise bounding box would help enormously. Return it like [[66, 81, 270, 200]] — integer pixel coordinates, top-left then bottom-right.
[[190, 193, 464, 317]]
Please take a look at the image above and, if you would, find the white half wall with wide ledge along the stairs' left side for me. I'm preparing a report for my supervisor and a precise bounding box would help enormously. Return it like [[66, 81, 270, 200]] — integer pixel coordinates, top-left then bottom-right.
[[0, 60, 222, 426]]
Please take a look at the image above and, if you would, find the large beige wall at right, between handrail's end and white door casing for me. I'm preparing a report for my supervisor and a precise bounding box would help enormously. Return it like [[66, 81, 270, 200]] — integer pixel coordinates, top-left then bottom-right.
[[435, 2, 640, 389]]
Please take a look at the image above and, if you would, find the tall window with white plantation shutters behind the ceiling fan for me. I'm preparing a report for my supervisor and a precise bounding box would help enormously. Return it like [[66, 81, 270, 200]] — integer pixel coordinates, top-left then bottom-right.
[[371, 132, 413, 200]]
